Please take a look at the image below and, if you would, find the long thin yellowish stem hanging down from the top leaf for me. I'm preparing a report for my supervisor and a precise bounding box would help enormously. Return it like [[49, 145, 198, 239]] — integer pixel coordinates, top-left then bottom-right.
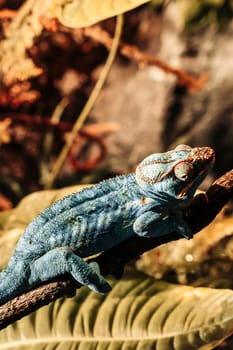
[[45, 15, 123, 188]]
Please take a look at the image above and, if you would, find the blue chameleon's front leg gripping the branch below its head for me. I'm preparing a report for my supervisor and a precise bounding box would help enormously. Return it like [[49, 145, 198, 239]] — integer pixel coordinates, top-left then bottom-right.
[[133, 210, 193, 239]]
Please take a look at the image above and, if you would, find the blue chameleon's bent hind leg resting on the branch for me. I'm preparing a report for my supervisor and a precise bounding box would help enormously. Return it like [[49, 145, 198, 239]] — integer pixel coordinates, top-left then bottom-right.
[[29, 247, 111, 293]]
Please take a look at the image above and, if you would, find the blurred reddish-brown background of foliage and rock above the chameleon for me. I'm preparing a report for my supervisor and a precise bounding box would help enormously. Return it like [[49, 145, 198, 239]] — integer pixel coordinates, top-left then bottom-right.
[[0, 0, 233, 209]]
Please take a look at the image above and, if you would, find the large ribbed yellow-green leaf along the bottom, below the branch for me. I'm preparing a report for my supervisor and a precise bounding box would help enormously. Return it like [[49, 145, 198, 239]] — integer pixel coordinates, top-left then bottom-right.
[[0, 271, 233, 350]]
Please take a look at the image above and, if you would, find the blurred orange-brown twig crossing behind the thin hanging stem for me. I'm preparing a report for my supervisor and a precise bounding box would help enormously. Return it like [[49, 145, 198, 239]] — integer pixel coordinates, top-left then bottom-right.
[[83, 26, 207, 92]]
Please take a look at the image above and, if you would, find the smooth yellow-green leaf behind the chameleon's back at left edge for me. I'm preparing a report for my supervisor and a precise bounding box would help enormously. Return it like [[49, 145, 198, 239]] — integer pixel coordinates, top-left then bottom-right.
[[0, 186, 87, 268]]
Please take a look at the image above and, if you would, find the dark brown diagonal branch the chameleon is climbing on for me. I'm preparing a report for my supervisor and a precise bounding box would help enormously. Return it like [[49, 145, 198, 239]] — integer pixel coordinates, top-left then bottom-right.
[[0, 170, 233, 329]]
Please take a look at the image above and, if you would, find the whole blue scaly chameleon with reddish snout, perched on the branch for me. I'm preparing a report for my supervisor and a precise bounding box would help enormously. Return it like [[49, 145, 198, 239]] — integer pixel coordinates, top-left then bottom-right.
[[0, 145, 215, 305]]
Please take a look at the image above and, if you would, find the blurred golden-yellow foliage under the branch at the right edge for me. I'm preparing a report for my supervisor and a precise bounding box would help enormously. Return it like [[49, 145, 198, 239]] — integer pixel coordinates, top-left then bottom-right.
[[137, 216, 233, 287]]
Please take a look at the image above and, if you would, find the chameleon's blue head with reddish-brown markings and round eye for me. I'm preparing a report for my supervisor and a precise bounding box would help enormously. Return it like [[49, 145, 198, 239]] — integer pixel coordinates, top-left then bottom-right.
[[136, 145, 215, 200]]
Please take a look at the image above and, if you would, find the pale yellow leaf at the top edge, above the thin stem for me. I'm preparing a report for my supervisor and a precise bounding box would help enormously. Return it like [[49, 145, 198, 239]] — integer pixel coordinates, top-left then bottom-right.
[[56, 0, 149, 28]]
